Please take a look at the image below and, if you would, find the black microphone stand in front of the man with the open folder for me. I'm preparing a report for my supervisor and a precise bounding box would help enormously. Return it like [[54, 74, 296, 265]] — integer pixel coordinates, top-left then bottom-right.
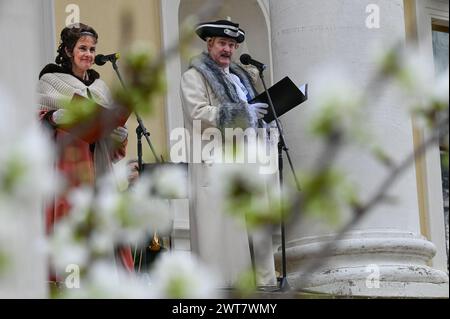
[[258, 66, 301, 291]]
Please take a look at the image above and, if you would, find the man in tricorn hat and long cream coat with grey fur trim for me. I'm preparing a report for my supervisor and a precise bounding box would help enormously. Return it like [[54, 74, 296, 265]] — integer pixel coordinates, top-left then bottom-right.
[[181, 20, 276, 287]]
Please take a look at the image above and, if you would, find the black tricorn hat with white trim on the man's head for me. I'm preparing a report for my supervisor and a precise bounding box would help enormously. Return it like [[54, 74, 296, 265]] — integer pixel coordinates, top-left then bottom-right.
[[195, 20, 245, 43]]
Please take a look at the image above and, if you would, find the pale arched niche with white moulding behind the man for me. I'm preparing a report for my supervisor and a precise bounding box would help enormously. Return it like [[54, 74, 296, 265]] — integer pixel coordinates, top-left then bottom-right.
[[161, 0, 272, 251]]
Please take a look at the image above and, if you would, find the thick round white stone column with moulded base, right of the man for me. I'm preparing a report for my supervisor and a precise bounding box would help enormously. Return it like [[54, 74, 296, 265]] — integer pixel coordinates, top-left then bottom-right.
[[270, 0, 448, 296]]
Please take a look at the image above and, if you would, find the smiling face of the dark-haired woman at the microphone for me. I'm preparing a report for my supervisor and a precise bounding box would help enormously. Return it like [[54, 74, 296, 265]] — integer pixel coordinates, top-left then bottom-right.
[[72, 36, 97, 76]]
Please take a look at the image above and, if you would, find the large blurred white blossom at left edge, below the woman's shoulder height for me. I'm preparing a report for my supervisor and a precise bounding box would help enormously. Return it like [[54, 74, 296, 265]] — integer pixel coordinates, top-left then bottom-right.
[[0, 86, 55, 207]]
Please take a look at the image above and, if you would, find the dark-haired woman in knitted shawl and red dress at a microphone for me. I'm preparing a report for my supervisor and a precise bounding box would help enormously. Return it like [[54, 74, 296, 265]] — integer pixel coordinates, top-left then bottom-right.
[[38, 23, 133, 278]]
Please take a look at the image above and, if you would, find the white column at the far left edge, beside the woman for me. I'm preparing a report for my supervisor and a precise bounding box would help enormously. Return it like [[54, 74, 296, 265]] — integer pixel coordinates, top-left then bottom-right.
[[0, 0, 55, 298]]
